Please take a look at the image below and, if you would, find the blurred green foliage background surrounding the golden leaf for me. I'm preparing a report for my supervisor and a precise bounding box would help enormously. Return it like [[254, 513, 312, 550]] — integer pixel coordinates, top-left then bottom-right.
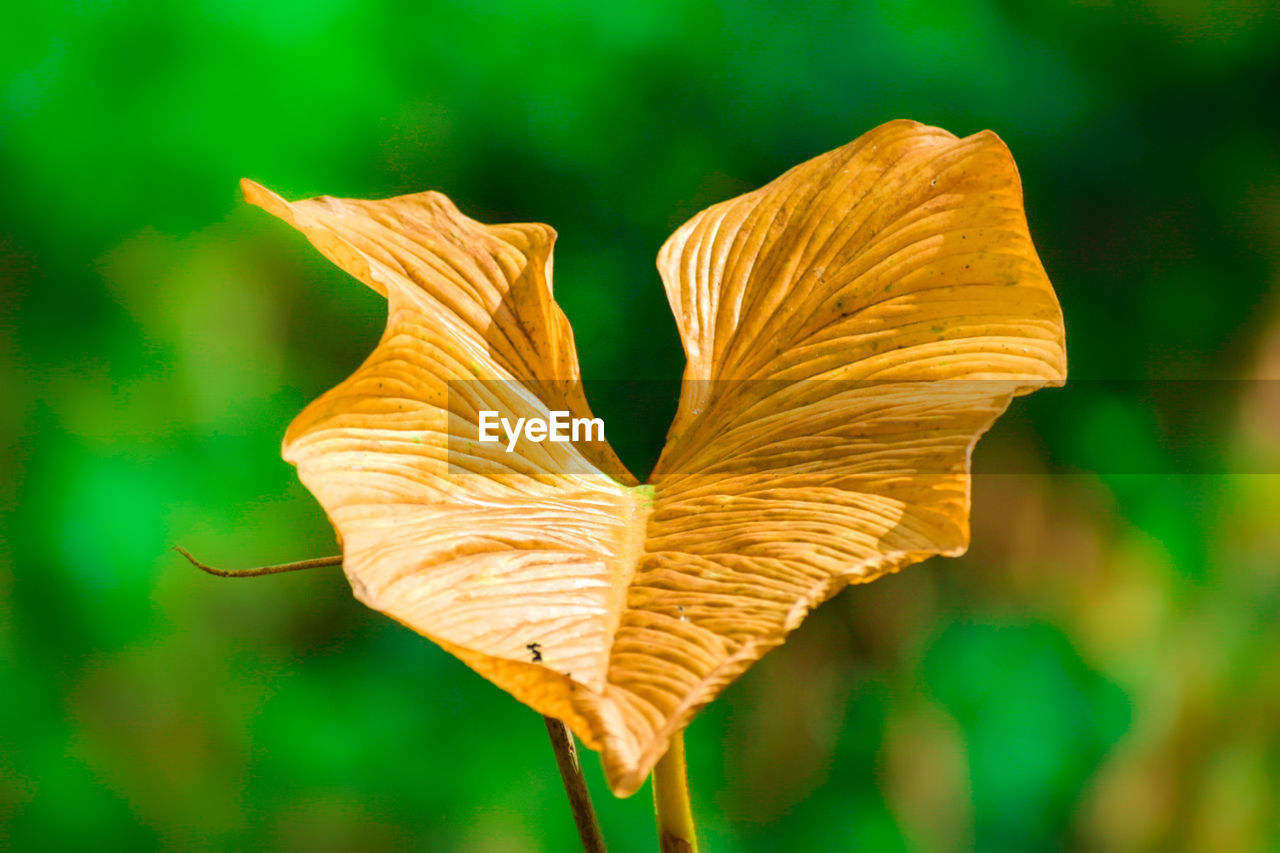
[[0, 0, 1280, 853]]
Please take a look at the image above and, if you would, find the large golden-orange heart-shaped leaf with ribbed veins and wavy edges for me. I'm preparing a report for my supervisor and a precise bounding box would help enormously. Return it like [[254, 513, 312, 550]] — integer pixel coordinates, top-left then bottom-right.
[[244, 122, 1066, 795]]
